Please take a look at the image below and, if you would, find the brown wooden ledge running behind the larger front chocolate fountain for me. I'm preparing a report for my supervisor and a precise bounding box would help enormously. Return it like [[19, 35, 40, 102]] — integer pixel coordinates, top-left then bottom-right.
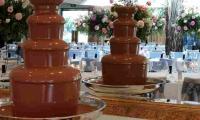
[[0, 89, 200, 120]]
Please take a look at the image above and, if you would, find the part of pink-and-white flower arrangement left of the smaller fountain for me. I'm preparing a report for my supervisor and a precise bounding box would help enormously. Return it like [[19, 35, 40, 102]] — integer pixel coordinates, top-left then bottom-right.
[[75, 8, 117, 37]]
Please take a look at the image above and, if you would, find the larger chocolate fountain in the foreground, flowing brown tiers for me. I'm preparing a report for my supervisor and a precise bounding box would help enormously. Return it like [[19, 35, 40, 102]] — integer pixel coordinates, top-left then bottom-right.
[[10, 0, 80, 117]]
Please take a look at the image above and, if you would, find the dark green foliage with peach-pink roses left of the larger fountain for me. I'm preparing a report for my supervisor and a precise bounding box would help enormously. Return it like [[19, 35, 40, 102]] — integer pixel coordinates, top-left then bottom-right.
[[0, 0, 32, 42]]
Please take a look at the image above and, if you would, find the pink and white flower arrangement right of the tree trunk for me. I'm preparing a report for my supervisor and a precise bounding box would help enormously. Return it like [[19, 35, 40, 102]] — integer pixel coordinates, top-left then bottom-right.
[[176, 12, 200, 34]]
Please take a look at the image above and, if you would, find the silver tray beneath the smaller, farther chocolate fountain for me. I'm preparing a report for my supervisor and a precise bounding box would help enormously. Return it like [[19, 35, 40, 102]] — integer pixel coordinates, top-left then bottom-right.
[[82, 76, 164, 96]]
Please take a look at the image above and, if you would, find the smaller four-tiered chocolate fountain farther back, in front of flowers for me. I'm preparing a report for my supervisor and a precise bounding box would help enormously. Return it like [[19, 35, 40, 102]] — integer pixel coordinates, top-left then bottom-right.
[[102, 7, 147, 85]]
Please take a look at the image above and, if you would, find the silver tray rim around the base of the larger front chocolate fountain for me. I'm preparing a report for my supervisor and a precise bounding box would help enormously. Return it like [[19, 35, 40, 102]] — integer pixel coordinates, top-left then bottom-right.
[[0, 96, 106, 120]]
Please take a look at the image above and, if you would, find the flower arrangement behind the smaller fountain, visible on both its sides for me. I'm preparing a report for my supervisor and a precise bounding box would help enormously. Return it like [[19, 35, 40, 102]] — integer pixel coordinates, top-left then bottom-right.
[[76, 0, 152, 40]]
